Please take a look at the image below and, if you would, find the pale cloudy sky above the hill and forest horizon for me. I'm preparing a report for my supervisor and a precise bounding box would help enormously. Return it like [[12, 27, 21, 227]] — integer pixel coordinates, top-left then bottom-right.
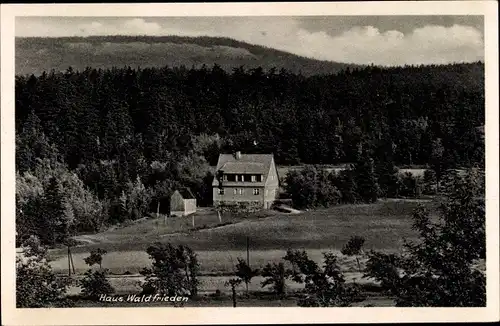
[[15, 15, 484, 66]]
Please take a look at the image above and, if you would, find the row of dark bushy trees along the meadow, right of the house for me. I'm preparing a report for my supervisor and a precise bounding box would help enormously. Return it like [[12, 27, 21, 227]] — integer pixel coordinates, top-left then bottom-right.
[[284, 148, 478, 208]]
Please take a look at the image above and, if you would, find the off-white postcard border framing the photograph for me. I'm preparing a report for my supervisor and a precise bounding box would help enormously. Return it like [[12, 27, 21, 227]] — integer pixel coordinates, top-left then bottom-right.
[[1, 1, 500, 325]]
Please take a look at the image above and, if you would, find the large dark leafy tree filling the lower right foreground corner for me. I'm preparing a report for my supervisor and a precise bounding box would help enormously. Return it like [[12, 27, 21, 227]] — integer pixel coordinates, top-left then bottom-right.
[[366, 172, 486, 307]]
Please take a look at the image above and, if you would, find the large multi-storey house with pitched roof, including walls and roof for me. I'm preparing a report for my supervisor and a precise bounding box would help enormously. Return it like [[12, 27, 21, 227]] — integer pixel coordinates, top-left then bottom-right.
[[212, 152, 279, 209]]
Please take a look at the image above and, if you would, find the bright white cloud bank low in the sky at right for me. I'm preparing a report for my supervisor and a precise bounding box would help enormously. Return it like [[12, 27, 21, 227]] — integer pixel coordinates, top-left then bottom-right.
[[242, 25, 484, 65]]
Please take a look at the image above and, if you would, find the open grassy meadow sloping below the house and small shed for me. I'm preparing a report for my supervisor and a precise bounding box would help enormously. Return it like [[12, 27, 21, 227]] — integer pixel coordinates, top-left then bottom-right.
[[50, 200, 435, 275]]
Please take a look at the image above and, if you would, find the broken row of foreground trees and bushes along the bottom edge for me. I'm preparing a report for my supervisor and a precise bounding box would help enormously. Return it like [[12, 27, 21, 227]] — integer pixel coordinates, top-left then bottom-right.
[[16, 171, 486, 307]]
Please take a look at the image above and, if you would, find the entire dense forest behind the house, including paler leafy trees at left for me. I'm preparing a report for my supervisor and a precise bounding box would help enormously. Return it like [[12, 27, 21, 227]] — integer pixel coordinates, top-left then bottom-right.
[[15, 63, 485, 243]]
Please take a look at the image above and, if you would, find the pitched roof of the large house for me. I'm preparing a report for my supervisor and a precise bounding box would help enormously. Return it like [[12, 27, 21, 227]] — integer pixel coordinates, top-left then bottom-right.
[[212, 154, 273, 186]]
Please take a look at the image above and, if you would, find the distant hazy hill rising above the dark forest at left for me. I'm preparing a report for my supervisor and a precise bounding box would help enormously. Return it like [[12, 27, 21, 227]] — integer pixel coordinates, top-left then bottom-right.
[[16, 36, 360, 76]]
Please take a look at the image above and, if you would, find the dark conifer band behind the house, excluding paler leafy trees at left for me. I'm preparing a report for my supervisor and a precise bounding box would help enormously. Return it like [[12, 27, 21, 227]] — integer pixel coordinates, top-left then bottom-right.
[[15, 63, 484, 171]]
